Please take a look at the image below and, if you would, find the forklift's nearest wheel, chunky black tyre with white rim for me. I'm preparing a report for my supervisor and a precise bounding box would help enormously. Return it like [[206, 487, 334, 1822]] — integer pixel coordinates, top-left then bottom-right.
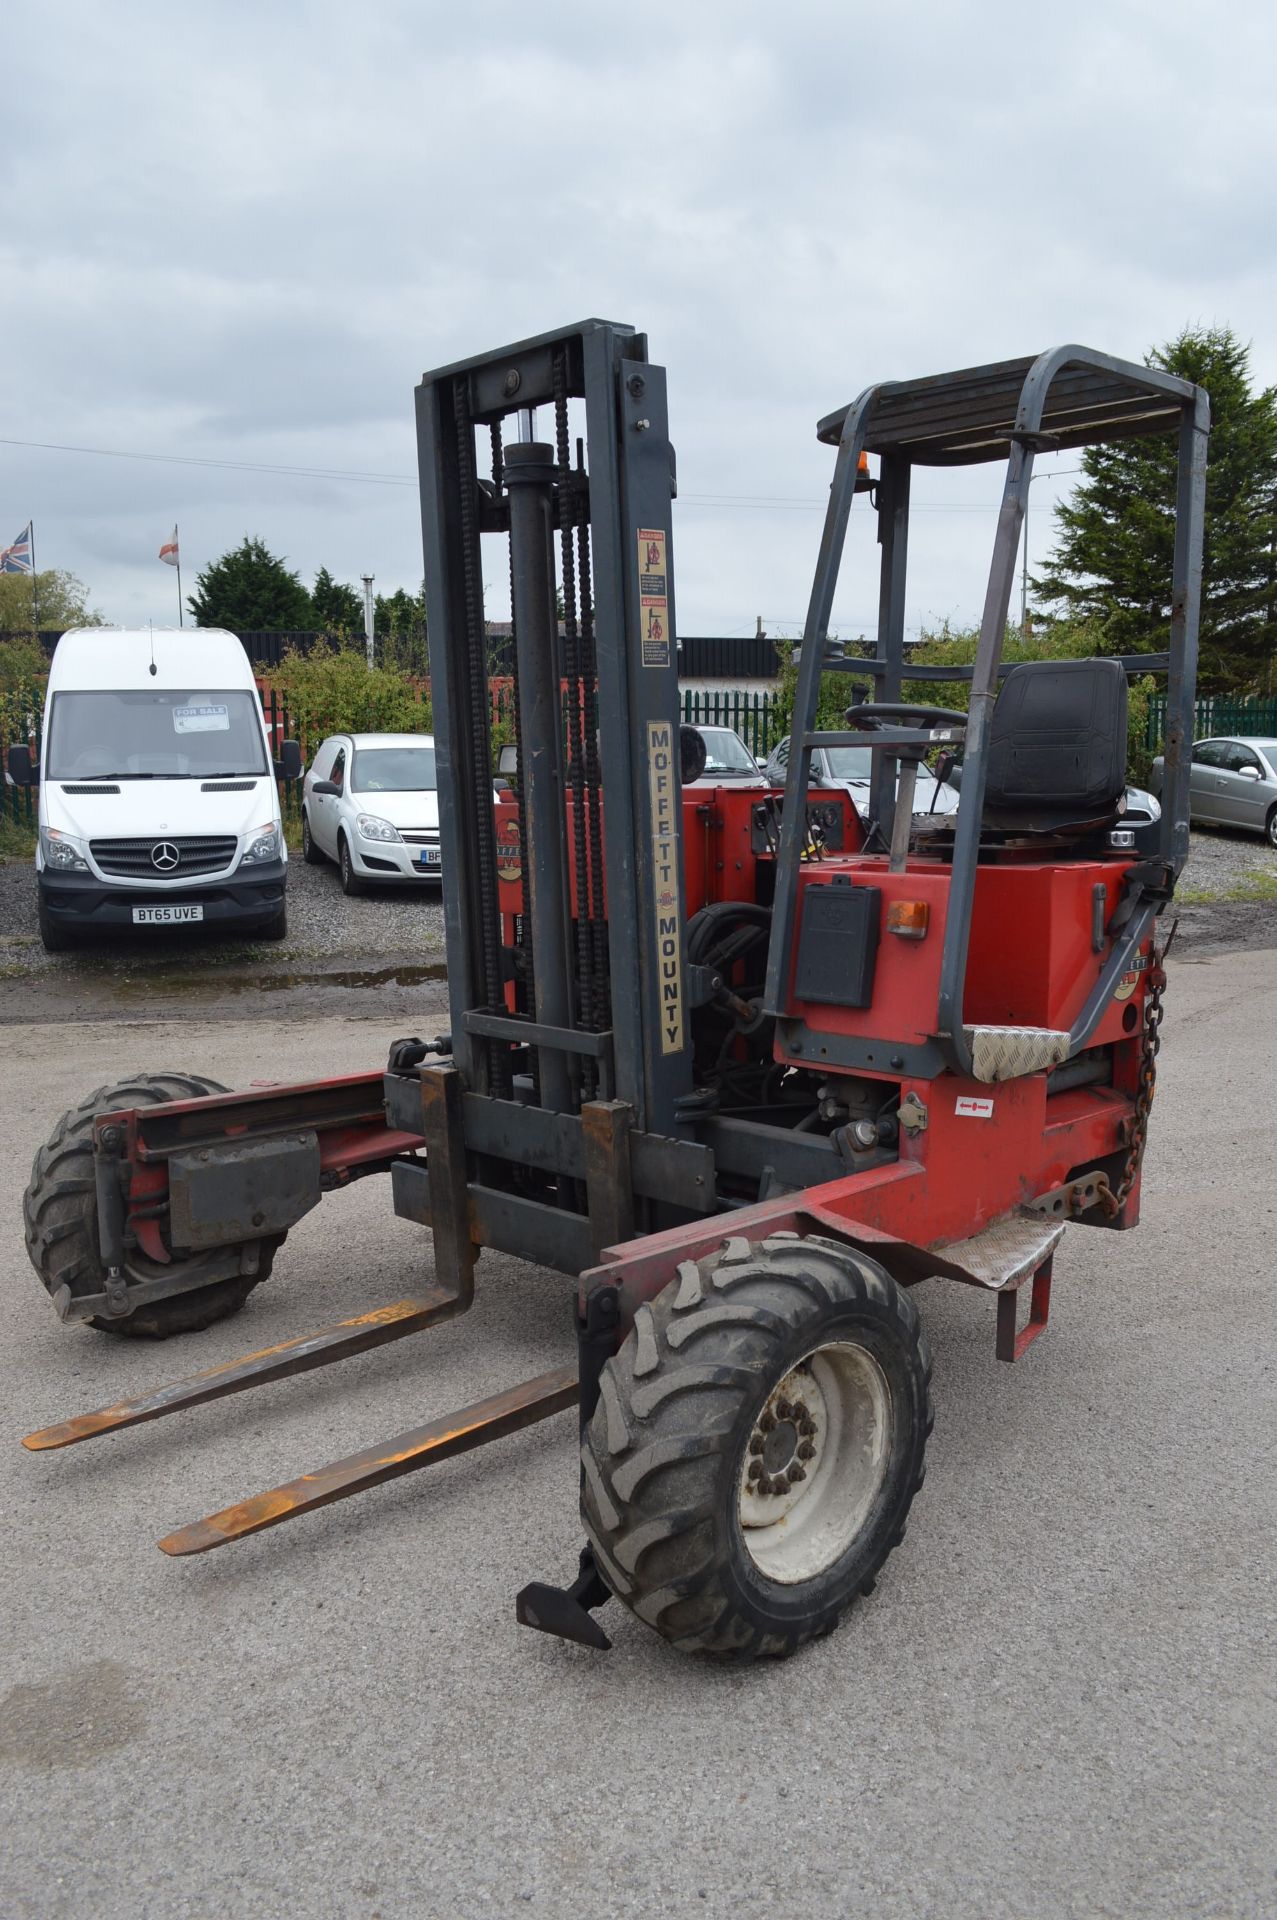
[[582, 1233, 931, 1661]]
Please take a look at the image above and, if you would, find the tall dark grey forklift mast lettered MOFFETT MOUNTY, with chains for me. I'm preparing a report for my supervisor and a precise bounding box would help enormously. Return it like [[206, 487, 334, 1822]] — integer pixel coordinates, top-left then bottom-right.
[[417, 321, 691, 1137]]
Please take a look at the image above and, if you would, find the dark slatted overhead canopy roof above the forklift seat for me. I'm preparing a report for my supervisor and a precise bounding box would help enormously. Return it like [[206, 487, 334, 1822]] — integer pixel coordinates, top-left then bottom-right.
[[816, 348, 1194, 467]]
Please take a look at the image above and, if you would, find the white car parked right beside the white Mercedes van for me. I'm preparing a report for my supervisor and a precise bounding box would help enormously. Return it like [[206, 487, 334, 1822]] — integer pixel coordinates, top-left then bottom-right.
[[301, 733, 442, 893]]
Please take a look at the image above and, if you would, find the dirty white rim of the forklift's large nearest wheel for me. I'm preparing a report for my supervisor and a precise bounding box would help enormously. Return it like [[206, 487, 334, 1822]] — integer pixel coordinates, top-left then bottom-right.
[[737, 1340, 891, 1586]]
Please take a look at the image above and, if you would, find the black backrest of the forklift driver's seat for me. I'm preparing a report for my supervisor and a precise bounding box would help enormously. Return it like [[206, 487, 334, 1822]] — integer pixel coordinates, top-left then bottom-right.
[[985, 660, 1127, 826]]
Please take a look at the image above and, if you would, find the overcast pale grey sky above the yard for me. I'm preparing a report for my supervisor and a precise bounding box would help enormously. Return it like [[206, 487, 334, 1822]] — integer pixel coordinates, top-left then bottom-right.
[[0, 0, 1277, 634]]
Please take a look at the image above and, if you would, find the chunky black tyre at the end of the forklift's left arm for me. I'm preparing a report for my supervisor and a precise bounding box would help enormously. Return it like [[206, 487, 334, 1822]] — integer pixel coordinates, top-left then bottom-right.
[[23, 1073, 284, 1340]]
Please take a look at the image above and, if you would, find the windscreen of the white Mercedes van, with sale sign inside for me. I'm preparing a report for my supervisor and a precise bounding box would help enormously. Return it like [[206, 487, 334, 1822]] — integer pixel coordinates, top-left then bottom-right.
[[46, 687, 267, 780]]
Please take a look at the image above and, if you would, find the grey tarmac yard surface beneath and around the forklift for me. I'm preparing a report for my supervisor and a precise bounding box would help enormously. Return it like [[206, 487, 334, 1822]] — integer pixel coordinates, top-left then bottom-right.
[[0, 948, 1277, 1920]]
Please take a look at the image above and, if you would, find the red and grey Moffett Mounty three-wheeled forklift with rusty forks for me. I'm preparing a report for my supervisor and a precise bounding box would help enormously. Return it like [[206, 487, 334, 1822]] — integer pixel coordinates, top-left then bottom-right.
[[25, 321, 1208, 1659]]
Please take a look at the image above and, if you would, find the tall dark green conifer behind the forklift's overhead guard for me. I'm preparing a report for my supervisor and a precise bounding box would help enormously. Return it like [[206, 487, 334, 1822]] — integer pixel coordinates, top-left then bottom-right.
[[1033, 326, 1277, 693]]
